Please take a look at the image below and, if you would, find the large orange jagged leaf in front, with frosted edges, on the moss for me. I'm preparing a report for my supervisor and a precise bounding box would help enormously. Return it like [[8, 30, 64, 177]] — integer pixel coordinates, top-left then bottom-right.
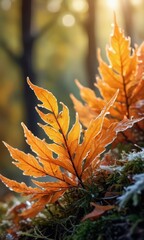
[[0, 80, 142, 218]]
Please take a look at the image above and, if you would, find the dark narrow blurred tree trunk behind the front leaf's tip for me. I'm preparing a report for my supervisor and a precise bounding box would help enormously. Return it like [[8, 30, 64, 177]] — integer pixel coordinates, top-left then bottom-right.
[[21, 0, 38, 134]]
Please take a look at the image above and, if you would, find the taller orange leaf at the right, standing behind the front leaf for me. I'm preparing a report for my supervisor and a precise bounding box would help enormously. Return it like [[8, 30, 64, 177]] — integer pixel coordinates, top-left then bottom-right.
[[71, 16, 144, 144]]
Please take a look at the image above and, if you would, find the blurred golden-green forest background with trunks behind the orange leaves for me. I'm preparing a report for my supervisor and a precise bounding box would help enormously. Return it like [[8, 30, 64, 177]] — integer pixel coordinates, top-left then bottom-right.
[[0, 0, 144, 195]]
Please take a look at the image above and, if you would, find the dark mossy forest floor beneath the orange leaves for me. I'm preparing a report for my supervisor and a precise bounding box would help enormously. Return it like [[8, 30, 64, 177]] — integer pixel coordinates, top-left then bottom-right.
[[0, 145, 144, 240]]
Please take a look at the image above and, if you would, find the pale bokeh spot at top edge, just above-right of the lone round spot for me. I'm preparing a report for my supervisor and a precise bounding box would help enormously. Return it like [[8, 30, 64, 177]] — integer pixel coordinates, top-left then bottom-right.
[[71, 0, 88, 12]]
